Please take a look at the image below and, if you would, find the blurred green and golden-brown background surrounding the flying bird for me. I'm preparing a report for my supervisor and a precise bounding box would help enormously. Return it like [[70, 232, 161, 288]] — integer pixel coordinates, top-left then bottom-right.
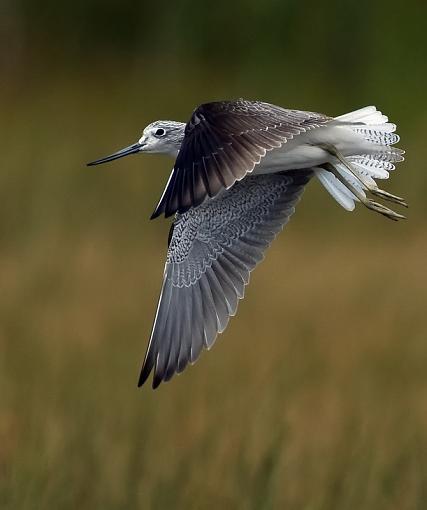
[[0, 0, 427, 510]]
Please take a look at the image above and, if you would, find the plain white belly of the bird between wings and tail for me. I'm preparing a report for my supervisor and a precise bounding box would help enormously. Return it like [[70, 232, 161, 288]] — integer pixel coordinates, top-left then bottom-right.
[[254, 126, 373, 174]]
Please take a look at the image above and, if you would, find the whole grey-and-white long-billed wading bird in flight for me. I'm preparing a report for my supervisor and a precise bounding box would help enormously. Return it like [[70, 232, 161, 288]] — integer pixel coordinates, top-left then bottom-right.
[[88, 99, 407, 388]]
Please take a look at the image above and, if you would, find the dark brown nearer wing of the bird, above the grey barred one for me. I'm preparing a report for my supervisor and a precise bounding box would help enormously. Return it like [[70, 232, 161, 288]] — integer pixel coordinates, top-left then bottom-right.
[[152, 100, 331, 218]]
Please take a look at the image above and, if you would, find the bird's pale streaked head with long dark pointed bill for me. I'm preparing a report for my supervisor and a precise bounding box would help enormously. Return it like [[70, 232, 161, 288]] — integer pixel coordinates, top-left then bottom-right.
[[88, 120, 185, 166]]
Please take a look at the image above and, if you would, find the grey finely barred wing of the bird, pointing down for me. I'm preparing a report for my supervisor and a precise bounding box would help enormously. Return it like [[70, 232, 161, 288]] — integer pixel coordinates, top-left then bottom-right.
[[139, 170, 311, 388]]
